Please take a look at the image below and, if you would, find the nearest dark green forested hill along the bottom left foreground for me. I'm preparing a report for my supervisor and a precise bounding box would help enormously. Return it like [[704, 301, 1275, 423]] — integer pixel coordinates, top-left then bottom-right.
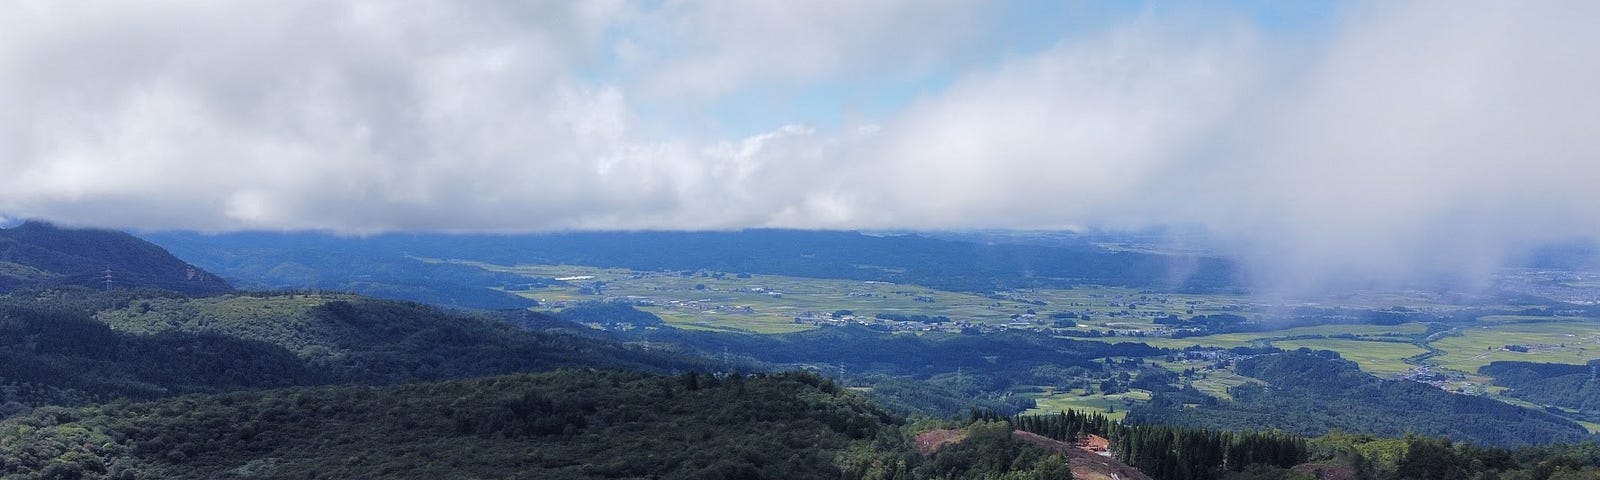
[[0, 370, 896, 478]]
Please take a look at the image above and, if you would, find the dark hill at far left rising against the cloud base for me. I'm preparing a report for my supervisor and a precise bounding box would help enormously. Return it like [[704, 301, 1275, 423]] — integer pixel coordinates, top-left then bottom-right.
[[0, 222, 234, 296]]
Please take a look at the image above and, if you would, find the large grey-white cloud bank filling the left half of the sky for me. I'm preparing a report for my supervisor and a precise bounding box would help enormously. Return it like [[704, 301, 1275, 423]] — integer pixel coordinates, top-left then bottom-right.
[[0, 2, 928, 232]]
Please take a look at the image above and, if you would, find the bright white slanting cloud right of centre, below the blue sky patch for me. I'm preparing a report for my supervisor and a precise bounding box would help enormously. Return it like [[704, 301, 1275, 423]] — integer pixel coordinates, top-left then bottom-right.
[[859, 18, 1261, 227]]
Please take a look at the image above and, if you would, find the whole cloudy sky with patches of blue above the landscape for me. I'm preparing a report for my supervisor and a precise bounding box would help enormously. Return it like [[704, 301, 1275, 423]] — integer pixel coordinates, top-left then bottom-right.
[[0, 0, 1600, 288]]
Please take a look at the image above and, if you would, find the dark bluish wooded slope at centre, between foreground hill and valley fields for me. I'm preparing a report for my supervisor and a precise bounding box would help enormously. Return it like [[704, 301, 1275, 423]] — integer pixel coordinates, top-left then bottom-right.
[[624, 326, 1162, 416]]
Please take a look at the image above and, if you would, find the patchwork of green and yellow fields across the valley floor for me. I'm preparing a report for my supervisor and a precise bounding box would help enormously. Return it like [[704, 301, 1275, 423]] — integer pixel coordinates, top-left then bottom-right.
[[462, 262, 1600, 416]]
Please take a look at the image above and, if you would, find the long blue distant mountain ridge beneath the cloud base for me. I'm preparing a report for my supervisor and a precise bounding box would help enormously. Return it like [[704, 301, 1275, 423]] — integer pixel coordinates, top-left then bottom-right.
[[142, 229, 1245, 306]]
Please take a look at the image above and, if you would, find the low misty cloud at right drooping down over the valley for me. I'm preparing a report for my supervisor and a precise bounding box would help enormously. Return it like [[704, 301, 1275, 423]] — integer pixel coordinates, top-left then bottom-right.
[[1195, 2, 1600, 288]]
